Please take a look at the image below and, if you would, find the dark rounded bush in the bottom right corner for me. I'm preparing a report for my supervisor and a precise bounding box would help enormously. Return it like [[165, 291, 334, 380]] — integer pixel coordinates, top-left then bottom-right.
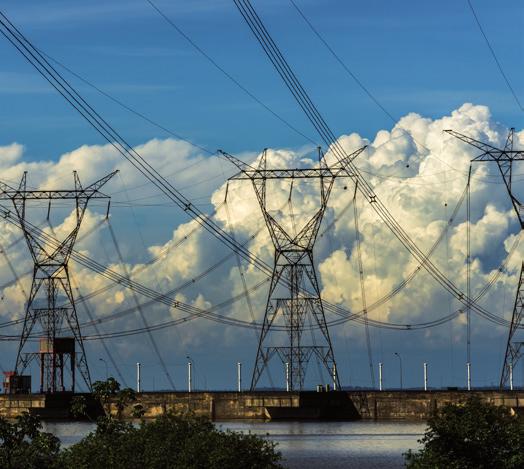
[[405, 398, 524, 469]]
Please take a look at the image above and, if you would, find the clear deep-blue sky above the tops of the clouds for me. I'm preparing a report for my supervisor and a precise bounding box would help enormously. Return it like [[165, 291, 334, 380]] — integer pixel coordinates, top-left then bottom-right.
[[0, 0, 524, 158]]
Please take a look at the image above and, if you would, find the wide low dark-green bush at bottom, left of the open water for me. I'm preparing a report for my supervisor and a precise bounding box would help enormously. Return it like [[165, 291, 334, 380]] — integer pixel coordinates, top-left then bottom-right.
[[60, 414, 281, 469]]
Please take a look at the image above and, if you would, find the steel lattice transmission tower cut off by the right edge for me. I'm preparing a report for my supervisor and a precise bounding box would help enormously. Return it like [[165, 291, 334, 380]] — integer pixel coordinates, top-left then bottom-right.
[[445, 128, 524, 388]]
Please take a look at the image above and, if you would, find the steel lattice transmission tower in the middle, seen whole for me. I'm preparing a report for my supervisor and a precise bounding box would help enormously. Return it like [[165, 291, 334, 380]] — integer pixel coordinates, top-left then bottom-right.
[[221, 147, 365, 391]]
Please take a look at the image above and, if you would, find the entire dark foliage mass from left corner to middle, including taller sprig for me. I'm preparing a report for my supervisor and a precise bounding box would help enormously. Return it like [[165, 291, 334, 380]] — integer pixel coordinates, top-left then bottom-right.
[[0, 378, 282, 469]]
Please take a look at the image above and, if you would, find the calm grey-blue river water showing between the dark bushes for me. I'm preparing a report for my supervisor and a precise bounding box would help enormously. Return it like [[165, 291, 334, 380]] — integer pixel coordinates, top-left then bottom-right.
[[45, 421, 425, 469]]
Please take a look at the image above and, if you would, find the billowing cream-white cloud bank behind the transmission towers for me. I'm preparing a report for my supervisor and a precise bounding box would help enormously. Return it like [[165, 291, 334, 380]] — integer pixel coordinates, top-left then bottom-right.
[[0, 104, 524, 384]]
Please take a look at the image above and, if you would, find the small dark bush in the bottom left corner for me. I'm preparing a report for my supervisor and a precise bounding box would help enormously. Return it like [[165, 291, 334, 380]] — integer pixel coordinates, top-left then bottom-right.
[[0, 413, 60, 469]]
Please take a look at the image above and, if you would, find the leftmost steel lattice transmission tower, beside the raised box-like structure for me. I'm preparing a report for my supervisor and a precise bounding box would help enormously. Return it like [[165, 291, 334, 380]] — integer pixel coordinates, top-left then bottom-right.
[[0, 171, 117, 393]]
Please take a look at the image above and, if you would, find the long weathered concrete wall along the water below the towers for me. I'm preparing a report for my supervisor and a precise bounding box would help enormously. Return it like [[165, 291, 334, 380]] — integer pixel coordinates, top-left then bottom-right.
[[0, 390, 524, 420]]
